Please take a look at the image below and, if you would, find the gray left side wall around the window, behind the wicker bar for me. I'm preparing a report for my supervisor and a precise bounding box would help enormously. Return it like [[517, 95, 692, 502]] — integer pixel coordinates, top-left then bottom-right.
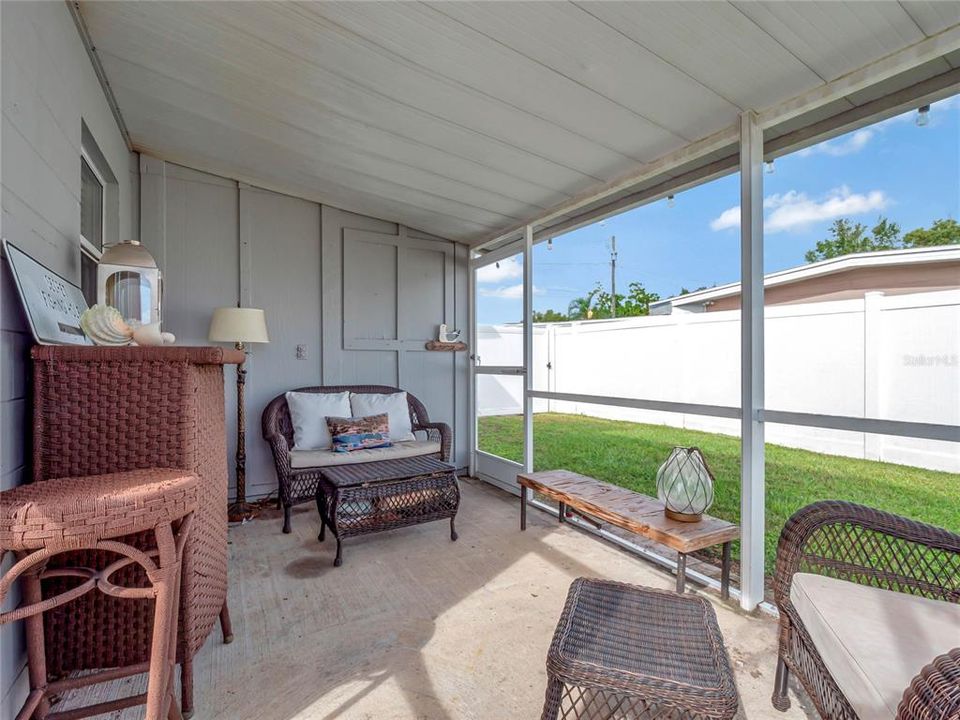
[[0, 2, 138, 717]]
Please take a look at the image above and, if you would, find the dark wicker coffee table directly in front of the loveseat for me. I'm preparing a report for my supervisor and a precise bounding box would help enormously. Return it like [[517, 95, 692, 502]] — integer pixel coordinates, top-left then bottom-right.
[[317, 457, 460, 567]]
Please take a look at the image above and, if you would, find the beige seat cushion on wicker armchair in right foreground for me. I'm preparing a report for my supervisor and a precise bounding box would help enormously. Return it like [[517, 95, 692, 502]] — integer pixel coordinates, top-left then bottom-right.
[[790, 573, 960, 720]]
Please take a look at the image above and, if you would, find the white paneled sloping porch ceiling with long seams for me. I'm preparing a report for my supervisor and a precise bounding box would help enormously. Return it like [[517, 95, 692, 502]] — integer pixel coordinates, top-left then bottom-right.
[[81, 1, 960, 242]]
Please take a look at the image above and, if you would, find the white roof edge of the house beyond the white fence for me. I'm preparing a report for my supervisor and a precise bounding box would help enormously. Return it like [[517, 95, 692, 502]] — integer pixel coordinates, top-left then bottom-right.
[[650, 245, 960, 312]]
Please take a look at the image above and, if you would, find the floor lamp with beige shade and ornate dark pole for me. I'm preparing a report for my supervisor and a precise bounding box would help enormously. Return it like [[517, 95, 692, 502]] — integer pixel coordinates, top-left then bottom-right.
[[208, 307, 270, 521]]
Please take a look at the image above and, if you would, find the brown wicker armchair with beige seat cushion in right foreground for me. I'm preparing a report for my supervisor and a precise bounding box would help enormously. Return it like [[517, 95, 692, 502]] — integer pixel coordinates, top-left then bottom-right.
[[773, 501, 960, 720]]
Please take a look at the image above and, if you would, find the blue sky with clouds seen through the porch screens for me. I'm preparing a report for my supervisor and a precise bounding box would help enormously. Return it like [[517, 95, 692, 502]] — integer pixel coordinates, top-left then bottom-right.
[[477, 96, 960, 324]]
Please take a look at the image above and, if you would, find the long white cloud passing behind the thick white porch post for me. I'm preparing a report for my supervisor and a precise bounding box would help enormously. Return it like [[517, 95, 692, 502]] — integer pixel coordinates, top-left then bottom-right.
[[710, 185, 890, 233]]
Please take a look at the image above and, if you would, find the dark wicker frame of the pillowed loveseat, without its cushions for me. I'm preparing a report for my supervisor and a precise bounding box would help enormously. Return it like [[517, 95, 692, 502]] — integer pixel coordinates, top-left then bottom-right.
[[261, 385, 453, 533]]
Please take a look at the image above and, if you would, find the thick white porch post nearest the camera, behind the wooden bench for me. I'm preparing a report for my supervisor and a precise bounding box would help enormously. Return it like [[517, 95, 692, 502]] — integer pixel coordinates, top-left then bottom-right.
[[740, 111, 765, 611]]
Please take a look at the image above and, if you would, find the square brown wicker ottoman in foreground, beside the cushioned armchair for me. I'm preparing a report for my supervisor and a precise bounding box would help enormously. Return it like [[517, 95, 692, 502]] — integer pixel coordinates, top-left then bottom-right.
[[542, 578, 738, 720]]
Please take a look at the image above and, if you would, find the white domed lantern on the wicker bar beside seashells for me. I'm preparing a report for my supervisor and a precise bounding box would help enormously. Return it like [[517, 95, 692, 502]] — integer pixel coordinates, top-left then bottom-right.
[[97, 240, 160, 325]]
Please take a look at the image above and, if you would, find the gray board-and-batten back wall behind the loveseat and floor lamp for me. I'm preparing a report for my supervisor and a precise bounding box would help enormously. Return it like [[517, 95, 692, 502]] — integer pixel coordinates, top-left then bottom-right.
[[141, 165, 468, 497]]
